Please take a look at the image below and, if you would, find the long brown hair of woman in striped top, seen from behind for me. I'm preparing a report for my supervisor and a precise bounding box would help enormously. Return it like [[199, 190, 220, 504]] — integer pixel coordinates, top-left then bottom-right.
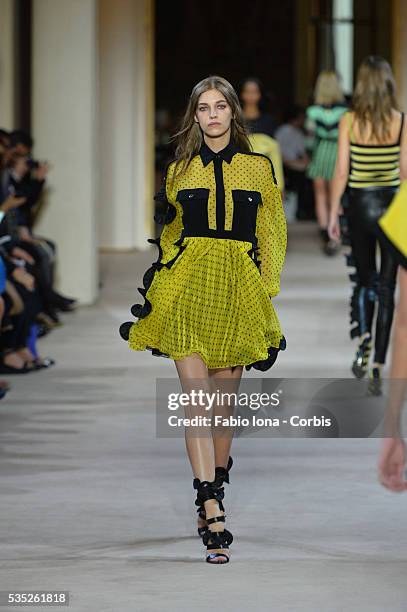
[[352, 55, 397, 140]]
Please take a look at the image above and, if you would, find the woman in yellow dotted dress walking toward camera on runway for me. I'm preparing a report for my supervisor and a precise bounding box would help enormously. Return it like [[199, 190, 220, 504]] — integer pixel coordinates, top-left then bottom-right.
[[120, 77, 287, 563]]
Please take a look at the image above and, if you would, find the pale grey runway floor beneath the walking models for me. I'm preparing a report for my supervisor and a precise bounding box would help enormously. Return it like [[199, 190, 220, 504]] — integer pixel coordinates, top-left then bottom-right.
[[0, 223, 407, 612]]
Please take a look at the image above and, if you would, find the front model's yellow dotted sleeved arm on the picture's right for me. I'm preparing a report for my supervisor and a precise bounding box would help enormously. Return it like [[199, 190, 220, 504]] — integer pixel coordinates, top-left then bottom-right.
[[256, 158, 287, 297]]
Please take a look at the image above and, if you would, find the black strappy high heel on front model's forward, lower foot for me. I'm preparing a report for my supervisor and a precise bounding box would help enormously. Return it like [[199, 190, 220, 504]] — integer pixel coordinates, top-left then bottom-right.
[[194, 478, 233, 564]]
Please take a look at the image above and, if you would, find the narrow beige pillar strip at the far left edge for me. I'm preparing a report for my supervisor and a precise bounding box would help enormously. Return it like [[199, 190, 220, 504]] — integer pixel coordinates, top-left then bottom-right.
[[0, 0, 15, 130]]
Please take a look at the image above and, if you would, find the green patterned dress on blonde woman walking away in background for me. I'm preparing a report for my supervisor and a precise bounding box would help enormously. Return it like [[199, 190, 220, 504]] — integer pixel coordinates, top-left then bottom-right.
[[306, 104, 348, 180]]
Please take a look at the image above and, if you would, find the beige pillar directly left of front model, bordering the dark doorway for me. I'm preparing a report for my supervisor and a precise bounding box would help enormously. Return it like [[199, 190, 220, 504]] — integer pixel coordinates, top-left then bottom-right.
[[98, 0, 154, 250]]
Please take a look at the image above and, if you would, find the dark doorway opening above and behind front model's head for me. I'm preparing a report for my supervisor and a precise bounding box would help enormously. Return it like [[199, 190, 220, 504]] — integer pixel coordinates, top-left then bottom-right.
[[156, 0, 295, 122]]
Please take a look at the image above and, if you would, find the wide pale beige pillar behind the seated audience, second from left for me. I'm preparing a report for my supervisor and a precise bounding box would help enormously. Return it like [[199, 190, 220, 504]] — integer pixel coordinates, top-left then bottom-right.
[[32, 0, 98, 304]]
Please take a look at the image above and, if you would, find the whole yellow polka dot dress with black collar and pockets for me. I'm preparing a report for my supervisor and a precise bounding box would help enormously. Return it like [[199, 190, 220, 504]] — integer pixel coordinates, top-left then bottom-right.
[[120, 141, 287, 371]]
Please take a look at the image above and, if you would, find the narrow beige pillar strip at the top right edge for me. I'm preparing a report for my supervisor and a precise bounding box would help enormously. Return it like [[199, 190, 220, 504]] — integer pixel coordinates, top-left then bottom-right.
[[392, 0, 407, 111]]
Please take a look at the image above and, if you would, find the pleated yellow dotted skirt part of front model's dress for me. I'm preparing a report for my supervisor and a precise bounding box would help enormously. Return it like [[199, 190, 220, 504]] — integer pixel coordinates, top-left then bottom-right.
[[124, 237, 285, 370]]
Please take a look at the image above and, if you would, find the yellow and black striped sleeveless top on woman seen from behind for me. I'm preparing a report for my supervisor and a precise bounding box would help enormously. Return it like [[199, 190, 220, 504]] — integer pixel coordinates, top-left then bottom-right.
[[347, 113, 404, 189]]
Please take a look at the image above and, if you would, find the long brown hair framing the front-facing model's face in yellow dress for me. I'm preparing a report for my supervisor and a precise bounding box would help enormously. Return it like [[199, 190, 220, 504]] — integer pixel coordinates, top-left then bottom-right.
[[172, 75, 252, 179]]
